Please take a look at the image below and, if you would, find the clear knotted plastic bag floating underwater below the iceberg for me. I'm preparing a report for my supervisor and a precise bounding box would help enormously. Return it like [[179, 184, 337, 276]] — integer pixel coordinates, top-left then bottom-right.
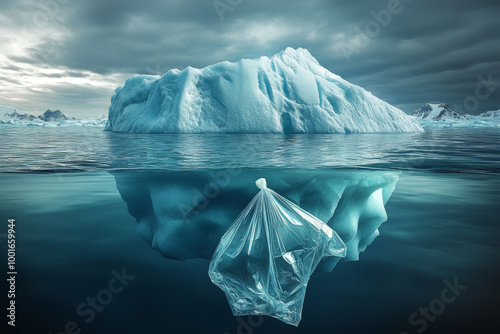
[[209, 179, 346, 326]]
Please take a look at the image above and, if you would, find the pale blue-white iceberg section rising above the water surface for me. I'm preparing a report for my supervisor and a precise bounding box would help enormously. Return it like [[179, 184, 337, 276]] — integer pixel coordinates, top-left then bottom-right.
[[106, 48, 422, 133]]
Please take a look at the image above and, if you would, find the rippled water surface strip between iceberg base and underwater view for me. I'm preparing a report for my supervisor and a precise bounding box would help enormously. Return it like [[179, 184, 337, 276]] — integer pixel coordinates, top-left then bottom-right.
[[0, 126, 500, 173]]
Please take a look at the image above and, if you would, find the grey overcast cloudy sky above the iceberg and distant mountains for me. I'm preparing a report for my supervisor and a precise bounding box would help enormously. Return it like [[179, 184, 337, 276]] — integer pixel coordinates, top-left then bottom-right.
[[0, 0, 500, 116]]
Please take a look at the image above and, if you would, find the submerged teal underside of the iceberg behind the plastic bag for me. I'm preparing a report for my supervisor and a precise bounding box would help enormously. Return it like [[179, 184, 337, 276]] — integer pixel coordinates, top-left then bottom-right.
[[111, 169, 398, 271]]
